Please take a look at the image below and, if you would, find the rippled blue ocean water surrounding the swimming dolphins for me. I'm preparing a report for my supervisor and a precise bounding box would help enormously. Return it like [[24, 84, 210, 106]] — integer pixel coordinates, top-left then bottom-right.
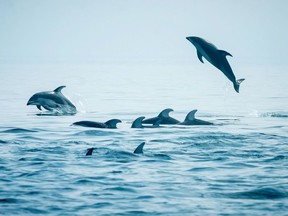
[[0, 62, 288, 215]]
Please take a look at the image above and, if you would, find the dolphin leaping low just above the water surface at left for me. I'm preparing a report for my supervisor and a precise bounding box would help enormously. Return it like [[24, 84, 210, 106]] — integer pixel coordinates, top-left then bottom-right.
[[27, 86, 77, 114]]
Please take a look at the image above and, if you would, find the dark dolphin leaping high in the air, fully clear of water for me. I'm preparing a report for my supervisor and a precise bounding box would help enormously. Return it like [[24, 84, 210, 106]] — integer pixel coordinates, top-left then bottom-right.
[[186, 36, 245, 93]]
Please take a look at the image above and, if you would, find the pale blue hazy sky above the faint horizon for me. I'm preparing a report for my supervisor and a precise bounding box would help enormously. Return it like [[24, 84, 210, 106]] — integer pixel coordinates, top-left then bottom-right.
[[0, 0, 288, 66]]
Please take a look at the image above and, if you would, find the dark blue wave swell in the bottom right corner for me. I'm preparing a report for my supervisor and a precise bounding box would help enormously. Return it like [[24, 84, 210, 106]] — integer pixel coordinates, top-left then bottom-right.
[[228, 187, 288, 200]]
